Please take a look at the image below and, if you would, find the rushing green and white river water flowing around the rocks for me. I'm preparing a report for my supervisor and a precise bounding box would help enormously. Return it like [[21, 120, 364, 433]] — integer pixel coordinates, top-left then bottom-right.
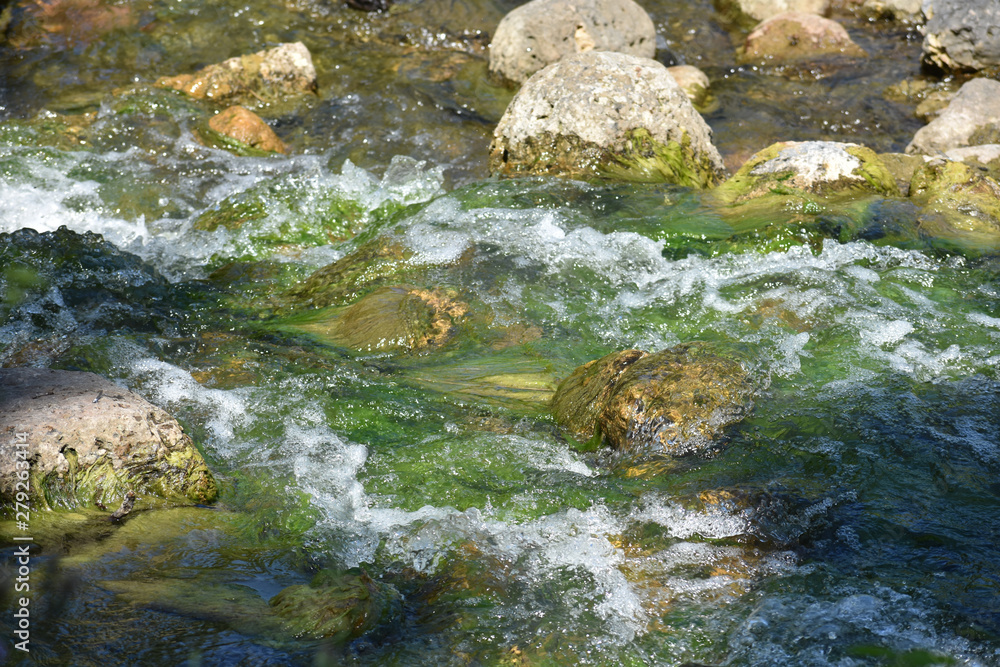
[[0, 0, 1000, 667]]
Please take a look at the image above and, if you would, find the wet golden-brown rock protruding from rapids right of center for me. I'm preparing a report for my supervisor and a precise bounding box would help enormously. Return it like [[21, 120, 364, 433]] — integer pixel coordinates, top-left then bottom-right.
[[552, 343, 756, 456]]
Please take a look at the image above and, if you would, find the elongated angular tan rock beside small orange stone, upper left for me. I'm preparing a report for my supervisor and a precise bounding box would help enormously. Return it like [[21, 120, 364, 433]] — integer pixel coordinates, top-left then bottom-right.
[[156, 42, 316, 104]]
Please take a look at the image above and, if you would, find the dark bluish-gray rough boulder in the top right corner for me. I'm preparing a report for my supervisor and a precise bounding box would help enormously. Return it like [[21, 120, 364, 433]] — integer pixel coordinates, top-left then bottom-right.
[[923, 0, 1000, 71]]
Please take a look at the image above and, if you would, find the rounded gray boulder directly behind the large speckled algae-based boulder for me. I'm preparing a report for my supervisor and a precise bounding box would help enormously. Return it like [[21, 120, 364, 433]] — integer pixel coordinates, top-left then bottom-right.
[[489, 0, 656, 84]]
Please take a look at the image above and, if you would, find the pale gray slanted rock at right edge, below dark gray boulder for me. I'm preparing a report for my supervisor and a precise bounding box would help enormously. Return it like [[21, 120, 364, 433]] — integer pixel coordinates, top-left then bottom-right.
[[906, 78, 1000, 155]]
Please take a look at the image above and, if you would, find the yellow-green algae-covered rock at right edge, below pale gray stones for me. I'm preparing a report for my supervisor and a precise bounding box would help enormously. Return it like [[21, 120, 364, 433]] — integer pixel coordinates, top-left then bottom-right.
[[910, 160, 1000, 254]]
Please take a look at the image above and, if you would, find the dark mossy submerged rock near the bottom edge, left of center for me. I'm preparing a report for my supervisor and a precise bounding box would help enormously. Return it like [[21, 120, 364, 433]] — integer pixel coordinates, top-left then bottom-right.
[[270, 571, 402, 642]]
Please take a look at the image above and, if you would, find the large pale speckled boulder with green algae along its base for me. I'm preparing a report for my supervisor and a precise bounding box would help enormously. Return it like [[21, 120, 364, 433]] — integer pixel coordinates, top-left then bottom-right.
[[490, 51, 725, 187]]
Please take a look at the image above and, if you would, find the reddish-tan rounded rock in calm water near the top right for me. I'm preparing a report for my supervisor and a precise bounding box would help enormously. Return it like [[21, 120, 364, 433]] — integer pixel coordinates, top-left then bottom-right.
[[737, 12, 868, 65]]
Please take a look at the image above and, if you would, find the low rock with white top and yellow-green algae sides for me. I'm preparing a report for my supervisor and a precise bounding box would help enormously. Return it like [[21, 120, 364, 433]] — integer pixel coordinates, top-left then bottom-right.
[[713, 141, 899, 204]]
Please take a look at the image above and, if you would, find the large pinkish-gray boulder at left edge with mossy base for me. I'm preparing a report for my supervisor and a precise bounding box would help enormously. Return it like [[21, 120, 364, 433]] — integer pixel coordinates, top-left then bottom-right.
[[0, 368, 217, 509]]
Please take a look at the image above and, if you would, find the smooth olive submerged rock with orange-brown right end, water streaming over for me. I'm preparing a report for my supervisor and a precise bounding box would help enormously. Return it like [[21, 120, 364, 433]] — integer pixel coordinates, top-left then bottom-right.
[[293, 285, 468, 352]]
